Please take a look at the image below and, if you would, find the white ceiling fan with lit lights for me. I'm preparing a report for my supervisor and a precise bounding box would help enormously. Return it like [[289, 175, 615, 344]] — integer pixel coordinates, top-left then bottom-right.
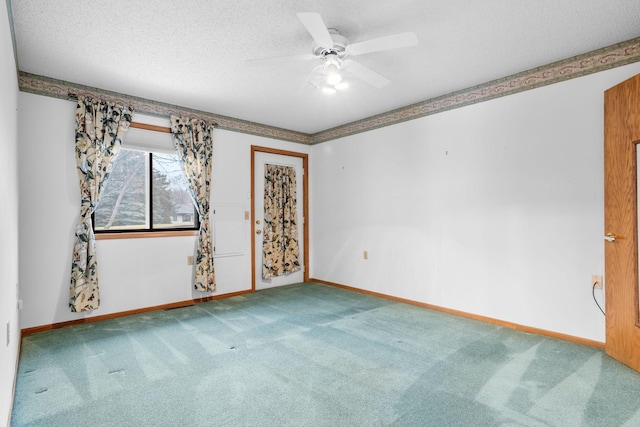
[[246, 12, 418, 93]]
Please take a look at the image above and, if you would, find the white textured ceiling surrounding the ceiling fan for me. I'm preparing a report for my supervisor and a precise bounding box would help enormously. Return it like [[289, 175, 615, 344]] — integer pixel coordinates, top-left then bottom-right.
[[10, 0, 640, 134]]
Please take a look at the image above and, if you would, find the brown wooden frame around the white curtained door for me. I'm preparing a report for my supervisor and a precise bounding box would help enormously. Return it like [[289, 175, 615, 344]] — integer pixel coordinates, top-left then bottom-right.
[[251, 145, 309, 291]]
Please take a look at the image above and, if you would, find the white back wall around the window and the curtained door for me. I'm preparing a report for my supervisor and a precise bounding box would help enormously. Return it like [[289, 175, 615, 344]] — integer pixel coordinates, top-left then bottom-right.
[[18, 93, 310, 328]]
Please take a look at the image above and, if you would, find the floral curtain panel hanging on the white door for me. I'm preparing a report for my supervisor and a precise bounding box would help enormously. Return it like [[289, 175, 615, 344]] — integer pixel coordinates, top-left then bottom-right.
[[262, 164, 300, 279]]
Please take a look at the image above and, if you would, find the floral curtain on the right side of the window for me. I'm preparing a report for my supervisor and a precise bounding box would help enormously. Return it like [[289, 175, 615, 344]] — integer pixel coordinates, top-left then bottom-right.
[[171, 116, 216, 292]]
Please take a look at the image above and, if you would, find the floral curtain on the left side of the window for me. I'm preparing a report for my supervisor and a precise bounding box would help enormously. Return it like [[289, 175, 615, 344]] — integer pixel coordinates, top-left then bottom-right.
[[69, 97, 133, 312]]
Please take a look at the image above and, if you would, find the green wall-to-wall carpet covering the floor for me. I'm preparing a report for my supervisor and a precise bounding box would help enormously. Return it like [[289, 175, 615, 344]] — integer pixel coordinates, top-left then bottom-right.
[[11, 284, 640, 427]]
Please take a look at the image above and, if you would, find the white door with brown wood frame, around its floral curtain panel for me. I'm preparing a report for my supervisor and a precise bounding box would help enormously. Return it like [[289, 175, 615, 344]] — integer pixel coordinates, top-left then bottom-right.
[[251, 146, 309, 291]]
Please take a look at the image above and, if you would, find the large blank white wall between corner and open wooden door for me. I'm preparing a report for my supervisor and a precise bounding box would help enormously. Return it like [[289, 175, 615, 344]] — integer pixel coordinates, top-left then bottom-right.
[[310, 64, 640, 341]]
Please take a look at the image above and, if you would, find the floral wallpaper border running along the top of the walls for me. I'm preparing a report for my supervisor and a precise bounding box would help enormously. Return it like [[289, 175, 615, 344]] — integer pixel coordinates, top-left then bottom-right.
[[18, 37, 640, 145]]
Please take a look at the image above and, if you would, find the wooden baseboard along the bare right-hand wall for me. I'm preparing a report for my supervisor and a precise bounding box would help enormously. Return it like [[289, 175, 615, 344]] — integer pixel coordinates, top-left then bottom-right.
[[309, 278, 605, 350]]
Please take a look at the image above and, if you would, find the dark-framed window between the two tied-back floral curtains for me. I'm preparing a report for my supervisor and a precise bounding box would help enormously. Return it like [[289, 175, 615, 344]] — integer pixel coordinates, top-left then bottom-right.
[[93, 129, 199, 233]]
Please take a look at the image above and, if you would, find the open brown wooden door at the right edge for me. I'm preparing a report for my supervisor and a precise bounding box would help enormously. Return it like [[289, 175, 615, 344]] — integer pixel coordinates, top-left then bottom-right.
[[604, 74, 640, 371]]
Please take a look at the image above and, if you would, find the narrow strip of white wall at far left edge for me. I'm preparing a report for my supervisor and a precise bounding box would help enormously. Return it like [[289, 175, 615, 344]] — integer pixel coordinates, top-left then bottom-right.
[[0, 2, 20, 425]]
